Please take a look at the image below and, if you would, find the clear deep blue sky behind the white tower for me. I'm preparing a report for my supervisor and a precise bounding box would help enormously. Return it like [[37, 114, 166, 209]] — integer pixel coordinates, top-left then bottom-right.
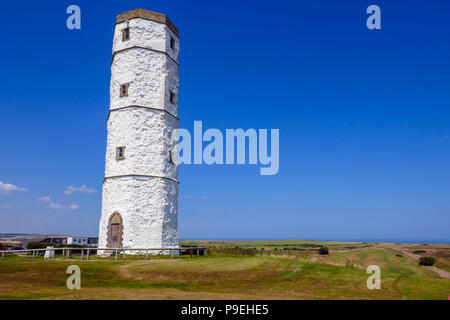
[[0, 0, 450, 242]]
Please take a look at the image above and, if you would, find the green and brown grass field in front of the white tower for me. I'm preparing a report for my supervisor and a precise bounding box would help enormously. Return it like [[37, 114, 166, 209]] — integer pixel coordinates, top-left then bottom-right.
[[0, 241, 450, 300]]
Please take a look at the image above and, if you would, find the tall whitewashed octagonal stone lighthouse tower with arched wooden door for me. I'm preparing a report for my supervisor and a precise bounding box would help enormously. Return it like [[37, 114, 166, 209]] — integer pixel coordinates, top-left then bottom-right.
[[98, 9, 179, 252]]
